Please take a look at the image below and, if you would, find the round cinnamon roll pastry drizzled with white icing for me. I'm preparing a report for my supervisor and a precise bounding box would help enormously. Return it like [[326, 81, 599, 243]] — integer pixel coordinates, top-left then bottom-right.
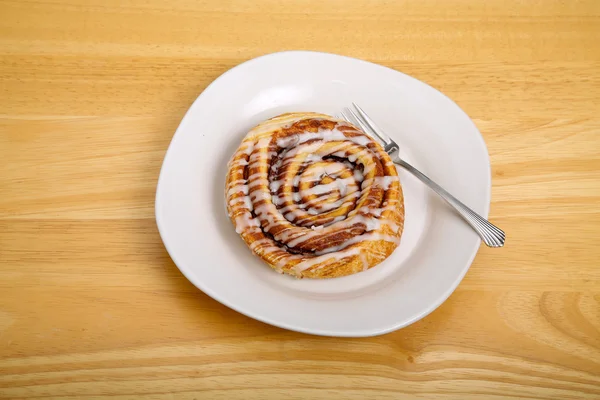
[[225, 113, 404, 278]]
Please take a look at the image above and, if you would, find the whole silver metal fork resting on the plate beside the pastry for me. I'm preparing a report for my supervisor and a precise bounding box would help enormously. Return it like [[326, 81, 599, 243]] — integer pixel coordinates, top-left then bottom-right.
[[341, 103, 506, 247]]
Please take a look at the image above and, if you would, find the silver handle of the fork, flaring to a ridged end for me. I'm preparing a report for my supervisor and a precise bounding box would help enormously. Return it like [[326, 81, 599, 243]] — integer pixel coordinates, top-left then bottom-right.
[[394, 158, 506, 247]]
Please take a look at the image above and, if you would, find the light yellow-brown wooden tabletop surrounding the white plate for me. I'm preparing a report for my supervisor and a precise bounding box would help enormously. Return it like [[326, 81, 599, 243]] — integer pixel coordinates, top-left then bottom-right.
[[0, 0, 600, 400]]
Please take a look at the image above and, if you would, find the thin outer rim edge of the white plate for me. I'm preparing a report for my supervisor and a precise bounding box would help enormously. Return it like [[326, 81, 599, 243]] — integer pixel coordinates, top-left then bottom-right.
[[154, 50, 492, 338]]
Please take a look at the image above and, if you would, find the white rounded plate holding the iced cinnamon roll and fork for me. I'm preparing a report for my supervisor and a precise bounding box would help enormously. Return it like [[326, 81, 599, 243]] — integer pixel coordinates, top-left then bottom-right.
[[156, 51, 491, 336]]
